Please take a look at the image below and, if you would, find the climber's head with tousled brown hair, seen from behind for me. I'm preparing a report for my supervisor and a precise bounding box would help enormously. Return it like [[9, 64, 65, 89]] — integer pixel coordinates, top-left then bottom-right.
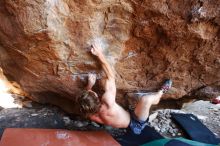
[[78, 90, 101, 117]]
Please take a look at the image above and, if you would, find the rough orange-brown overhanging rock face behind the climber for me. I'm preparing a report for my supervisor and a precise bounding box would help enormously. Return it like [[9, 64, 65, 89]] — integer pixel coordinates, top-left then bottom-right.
[[0, 0, 220, 112]]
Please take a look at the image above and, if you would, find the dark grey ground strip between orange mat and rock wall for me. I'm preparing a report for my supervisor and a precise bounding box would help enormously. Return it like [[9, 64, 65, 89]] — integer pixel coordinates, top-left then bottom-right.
[[0, 105, 124, 139]]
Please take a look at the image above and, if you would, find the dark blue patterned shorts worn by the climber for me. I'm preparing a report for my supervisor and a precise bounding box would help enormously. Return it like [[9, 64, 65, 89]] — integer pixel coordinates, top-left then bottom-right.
[[129, 111, 149, 135]]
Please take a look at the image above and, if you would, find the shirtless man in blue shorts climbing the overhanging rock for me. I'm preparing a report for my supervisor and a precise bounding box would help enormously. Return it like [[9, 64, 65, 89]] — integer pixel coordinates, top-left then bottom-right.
[[77, 46, 172, 134]]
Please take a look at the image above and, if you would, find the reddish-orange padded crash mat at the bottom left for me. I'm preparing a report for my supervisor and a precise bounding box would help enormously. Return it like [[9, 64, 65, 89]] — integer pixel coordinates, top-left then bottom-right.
[[0, 128, 120, 146]]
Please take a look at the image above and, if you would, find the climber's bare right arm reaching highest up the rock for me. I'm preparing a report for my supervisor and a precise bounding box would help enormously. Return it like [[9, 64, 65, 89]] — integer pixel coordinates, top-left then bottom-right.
[[91, 46, 116, 107]]
